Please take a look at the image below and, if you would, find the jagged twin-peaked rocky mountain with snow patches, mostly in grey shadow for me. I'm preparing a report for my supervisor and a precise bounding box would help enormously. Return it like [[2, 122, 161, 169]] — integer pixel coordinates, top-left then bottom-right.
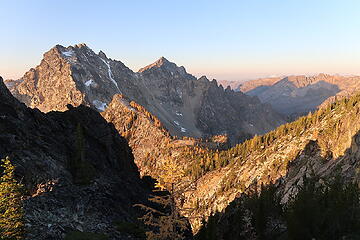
[[7, 44, 283, 143]]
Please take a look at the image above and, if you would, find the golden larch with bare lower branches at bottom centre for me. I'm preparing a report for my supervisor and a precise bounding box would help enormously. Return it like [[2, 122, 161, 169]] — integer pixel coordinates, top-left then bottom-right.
[[137, 160, 188, 240]]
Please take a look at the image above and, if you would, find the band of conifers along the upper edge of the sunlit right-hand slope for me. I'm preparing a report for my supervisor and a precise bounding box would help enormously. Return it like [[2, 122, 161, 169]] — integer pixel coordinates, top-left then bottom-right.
[[184, 95, 360, 180]]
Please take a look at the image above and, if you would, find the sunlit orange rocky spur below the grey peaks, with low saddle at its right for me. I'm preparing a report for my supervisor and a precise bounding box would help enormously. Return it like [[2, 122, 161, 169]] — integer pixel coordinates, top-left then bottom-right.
[[101, 94, 228, 178]]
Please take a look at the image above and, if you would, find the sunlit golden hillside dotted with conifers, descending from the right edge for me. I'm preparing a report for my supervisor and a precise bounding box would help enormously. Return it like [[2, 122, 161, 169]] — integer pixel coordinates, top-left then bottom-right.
[[181, 92, 360, 231]]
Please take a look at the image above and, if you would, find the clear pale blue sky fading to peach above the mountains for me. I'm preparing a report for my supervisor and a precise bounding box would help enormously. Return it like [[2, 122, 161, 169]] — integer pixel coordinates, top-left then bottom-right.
[[0, 0, 360, 81]]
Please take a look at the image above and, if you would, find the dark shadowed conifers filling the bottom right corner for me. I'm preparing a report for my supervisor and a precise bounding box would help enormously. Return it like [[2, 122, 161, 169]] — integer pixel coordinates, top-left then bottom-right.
[[196, 178, 360, 240]]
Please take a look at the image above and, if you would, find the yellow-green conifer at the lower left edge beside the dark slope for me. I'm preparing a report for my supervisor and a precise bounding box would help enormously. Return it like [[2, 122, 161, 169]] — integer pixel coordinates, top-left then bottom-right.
[[0, 157, 24, 240]]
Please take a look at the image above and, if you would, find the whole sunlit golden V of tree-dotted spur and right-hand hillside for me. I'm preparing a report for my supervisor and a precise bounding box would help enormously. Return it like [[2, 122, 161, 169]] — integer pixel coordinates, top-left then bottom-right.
[[86, 84, 360, 232]]
